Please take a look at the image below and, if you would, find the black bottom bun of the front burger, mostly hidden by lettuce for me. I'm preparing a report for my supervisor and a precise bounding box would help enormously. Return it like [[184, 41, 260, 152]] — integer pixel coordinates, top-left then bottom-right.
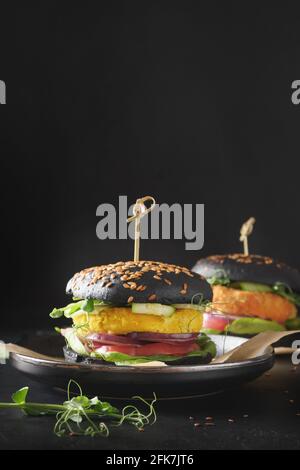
[[63, 346, 214, 367]]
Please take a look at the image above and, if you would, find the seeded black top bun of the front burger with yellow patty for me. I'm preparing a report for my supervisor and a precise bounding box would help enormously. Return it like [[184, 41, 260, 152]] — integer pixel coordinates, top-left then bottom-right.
[[66, 261, 212, 306]]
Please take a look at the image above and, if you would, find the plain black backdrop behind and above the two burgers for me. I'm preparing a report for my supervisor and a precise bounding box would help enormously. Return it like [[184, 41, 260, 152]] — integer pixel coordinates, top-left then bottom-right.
[[0, 1, 300, 328]]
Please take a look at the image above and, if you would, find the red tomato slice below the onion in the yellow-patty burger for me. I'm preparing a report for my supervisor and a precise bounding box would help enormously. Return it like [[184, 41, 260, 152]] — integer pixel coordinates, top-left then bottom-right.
[[96, 342, 199, 356]]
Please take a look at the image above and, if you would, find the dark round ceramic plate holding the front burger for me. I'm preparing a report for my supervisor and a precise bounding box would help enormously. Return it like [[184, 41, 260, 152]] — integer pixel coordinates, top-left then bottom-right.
[[10, 333, 274, 398]]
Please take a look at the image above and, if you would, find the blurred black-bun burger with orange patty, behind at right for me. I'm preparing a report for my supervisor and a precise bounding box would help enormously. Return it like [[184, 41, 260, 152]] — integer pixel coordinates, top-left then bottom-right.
[[193, 254, 300, 335]]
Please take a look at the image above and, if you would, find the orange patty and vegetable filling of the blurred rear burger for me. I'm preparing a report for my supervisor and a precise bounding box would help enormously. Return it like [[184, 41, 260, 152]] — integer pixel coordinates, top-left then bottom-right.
[[202, 276, 300, 335]]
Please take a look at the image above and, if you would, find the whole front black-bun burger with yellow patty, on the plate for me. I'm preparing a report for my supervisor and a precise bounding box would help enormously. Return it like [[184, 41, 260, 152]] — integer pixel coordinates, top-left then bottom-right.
[[50, 261, 216, 365]]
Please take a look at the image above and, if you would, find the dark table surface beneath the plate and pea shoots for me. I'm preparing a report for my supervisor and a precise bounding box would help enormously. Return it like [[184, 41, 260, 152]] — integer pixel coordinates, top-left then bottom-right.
[[0, 332, 300, 450]]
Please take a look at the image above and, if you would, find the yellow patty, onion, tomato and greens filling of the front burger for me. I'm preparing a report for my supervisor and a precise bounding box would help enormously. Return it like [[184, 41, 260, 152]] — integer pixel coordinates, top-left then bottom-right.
[[50, 300, 216, 365]]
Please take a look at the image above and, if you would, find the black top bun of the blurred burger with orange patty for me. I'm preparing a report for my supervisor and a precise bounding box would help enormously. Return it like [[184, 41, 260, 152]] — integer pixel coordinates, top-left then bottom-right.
[[192, 254, 300, 292]]
